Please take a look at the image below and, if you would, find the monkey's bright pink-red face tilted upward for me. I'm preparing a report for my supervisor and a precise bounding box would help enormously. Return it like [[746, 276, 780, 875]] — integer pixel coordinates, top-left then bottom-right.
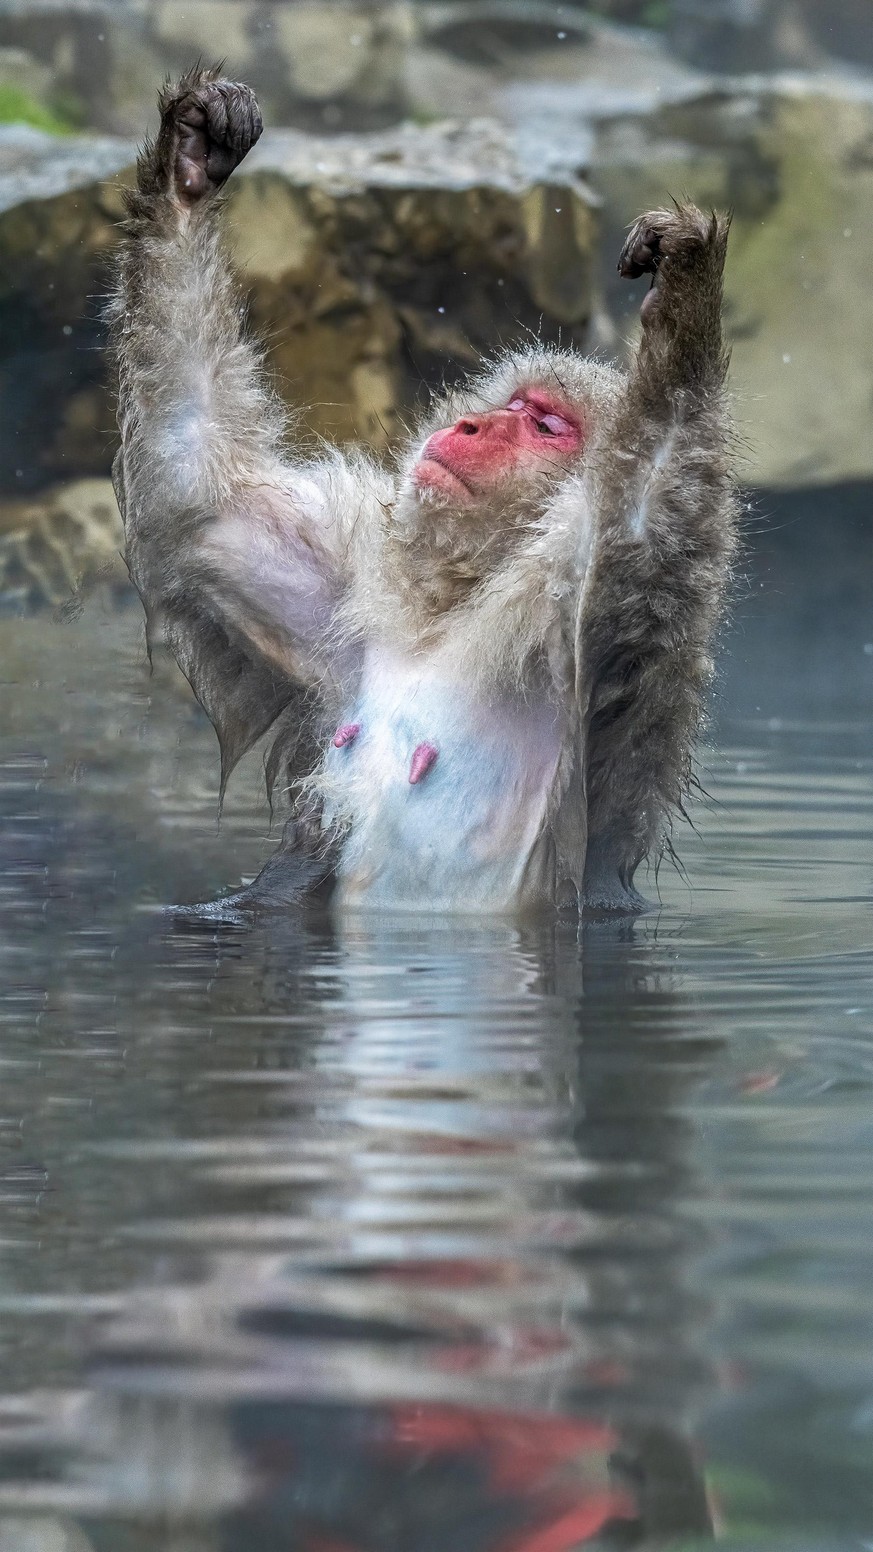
[[412, 390, 583, 504]]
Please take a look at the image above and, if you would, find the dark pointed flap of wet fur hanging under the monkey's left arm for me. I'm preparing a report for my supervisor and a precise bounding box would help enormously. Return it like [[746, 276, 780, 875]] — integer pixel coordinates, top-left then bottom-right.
[[163, 613, 300, 809]]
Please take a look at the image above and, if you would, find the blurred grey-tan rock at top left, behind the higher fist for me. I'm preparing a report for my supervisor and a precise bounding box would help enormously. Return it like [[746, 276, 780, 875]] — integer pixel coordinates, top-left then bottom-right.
[[0, 0, 416, 133]]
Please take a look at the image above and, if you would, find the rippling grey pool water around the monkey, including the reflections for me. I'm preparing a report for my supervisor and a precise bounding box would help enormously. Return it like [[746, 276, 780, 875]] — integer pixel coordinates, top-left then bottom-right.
[[0, 574, 873, 1552]]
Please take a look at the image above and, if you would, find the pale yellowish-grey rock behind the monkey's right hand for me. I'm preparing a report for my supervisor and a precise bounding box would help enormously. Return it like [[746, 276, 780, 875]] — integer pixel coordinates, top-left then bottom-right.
[[592, 76, 873, 487]]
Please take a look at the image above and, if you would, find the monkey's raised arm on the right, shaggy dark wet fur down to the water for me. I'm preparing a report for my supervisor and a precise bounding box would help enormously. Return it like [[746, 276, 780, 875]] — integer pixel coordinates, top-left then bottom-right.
[[576, 205, 736, 905]]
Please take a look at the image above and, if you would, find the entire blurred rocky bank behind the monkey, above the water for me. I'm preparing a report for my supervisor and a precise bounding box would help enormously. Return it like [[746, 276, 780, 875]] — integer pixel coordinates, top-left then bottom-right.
[[0, 0, 873, 685]]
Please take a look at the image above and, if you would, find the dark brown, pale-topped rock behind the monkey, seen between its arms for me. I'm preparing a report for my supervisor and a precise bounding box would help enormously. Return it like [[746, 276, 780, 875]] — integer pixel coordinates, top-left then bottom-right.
[[0, 121, 596, 490]]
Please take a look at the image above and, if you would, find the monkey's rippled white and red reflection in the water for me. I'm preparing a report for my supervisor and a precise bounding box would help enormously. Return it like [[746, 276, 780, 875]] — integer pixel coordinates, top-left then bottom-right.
[[73, 923, 711, 1552]]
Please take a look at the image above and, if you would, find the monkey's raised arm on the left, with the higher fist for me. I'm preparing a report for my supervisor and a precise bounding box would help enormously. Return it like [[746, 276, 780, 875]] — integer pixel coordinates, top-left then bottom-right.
[[109, 70, 358, 778]]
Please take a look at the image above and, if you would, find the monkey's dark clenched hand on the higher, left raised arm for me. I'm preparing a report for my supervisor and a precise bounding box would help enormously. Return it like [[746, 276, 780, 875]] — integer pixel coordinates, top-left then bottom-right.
[[154, 70, 264, 210]]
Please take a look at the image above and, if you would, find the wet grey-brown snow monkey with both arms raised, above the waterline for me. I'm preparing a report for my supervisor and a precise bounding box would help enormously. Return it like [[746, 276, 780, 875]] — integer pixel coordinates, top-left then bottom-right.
[[110, 70, 736, 913]]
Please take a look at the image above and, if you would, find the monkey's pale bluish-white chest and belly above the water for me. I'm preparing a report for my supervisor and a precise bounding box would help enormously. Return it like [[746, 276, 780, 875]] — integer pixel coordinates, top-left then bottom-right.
[[323, 649, 561, 913]]
